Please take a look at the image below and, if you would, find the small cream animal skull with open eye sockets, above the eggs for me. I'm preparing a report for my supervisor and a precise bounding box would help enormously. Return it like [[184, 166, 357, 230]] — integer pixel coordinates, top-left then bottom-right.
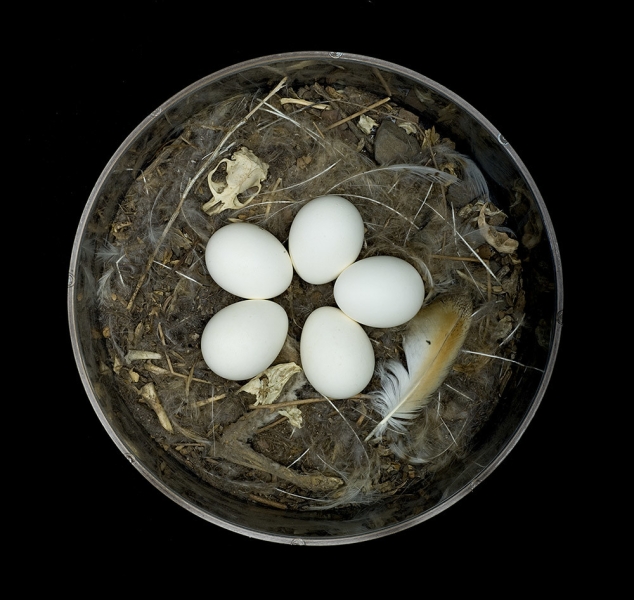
[[202, 146, 269, 215]]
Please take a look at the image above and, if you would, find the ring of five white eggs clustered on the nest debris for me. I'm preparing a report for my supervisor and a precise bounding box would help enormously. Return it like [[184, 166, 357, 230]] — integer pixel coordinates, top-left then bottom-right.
[[201, 195, 425, 398]]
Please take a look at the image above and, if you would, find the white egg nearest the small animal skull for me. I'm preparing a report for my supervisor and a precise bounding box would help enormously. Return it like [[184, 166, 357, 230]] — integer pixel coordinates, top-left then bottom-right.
[[205, 223, 293, 300]]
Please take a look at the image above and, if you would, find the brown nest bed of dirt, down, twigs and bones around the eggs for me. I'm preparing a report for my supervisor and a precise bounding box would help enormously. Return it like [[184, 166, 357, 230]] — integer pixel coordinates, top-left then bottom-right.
[[89, 79, 548, 514]]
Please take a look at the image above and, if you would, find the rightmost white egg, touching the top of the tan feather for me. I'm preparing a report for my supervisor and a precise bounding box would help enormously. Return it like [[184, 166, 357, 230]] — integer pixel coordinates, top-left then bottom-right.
[[334, 256, 425, 327]]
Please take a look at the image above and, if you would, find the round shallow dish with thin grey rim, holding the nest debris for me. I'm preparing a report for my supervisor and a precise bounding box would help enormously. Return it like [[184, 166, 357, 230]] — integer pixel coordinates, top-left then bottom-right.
[[68, 52, 563, 545]]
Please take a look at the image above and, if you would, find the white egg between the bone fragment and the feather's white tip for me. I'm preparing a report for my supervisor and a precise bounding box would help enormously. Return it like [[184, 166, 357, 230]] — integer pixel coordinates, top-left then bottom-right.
[[300, 306, 374, 398]]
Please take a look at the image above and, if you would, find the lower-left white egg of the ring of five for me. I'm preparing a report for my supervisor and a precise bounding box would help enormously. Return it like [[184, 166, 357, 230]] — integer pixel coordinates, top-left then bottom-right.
[[200, 300, 288, 381]]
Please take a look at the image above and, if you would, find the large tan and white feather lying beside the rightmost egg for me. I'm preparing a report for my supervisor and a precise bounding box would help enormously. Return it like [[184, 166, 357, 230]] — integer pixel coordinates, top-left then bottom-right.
[[366, 296, 472, 441]]
